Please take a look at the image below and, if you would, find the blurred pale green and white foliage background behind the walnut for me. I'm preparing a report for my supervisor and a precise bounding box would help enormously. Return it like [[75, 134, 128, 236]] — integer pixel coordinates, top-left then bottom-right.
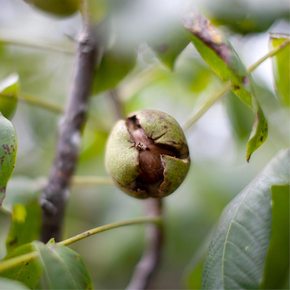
[[0, 0, 290, 289]]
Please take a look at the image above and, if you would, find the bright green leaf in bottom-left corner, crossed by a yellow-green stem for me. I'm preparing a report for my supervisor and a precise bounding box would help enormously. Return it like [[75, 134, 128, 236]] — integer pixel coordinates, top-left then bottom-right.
[[1, 244, 42, 289]]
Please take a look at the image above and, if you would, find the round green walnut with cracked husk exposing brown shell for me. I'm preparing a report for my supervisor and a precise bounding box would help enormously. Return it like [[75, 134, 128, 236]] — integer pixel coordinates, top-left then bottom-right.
[[105, 110, 190, 198]]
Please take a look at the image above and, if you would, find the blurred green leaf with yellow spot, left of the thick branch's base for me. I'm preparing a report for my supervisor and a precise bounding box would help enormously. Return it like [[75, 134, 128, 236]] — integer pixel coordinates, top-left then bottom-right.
[[3, 177, 43, 253]]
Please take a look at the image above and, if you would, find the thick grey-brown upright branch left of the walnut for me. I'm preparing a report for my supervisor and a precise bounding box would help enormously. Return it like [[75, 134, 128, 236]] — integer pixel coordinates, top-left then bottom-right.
[[40, 24, 98, 242]]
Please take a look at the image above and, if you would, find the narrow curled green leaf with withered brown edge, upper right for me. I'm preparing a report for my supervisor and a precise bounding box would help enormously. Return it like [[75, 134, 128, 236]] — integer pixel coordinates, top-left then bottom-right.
[[184, 16, 268, 161]]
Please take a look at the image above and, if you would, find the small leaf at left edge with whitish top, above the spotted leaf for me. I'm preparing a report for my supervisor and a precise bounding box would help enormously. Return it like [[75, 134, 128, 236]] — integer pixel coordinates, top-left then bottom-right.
[[0, 74, 20, 119]]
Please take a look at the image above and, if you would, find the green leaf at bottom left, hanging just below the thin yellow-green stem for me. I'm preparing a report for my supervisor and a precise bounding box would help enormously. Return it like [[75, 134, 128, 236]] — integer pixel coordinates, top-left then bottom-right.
[[34, 242, 92, 289]]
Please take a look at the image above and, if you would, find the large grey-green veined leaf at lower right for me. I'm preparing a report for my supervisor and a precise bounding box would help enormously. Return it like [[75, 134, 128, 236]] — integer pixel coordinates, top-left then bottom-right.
[[203, 149, 290, 289]]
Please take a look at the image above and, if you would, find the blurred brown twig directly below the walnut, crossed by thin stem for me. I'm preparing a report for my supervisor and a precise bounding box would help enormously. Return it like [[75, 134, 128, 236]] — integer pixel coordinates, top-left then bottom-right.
[[127, 199, 164, 290]]
